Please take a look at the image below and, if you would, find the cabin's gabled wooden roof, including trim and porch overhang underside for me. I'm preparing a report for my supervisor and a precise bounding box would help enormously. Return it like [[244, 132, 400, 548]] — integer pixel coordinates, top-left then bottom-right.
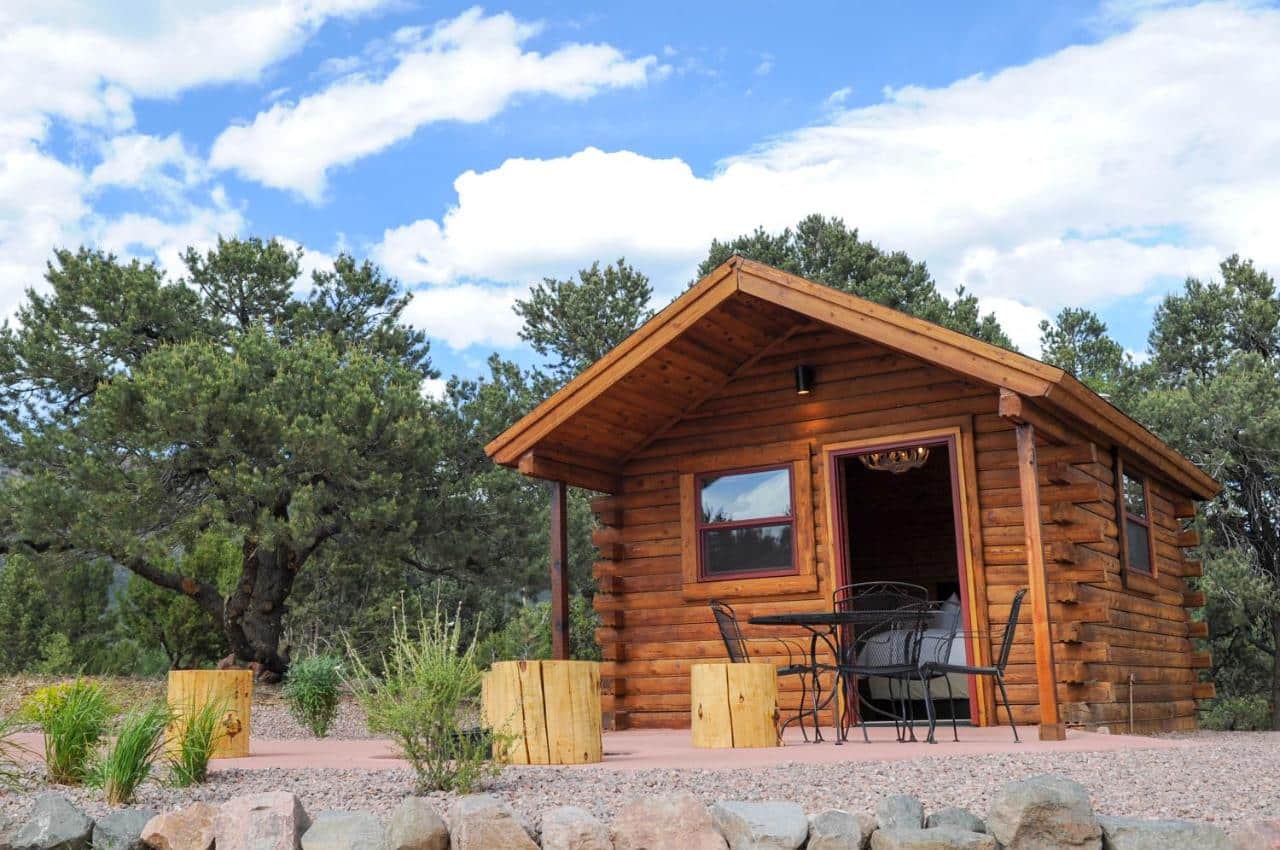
[[485, 256, 1220, 498]]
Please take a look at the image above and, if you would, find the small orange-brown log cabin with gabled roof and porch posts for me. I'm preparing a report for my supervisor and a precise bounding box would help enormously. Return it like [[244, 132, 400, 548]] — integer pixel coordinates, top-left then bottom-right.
[[486, 256, 1220, 739]]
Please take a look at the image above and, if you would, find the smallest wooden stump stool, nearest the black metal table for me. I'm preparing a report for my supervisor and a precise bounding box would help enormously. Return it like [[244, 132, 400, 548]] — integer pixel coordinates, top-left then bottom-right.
[[690, 664, 781, 748]]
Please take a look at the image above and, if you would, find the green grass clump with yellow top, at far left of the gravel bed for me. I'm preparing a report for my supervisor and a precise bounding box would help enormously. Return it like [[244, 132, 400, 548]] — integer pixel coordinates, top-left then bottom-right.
[[19, 678, 115, 785]]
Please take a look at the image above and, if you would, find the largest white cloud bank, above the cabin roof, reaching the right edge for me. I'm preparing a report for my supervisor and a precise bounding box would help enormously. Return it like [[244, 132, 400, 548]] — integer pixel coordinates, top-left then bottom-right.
[[376, 5, 1280, 347]]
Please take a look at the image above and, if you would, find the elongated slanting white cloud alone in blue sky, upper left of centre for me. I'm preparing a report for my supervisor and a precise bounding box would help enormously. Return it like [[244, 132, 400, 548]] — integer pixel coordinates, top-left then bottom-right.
[[210, 9, 657, 201]]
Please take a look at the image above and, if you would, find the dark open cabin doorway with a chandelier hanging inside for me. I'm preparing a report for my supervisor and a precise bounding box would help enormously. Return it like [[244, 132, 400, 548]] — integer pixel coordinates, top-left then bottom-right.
[[832, 437, 973, 721]]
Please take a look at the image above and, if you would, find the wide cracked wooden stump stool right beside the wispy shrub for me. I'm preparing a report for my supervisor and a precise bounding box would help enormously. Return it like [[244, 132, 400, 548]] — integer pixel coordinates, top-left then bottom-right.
[[480, 661, 604, 764]]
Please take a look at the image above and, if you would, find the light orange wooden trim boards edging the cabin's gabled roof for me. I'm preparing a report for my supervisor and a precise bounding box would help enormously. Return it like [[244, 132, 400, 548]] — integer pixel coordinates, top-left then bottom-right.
[[485, 256, 1221, 498]]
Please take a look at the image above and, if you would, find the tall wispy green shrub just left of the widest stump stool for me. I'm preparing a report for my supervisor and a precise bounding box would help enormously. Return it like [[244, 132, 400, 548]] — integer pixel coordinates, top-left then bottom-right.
[[348, 603, 498, 794]]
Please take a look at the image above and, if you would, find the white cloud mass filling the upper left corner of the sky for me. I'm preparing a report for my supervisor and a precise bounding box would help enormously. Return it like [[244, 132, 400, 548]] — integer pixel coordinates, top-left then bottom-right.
[[0, 0, 388, 319]]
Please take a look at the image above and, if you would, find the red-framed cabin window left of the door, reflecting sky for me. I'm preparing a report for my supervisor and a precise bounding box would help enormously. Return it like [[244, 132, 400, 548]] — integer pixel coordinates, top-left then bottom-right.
[[696, 465, 796, 579]]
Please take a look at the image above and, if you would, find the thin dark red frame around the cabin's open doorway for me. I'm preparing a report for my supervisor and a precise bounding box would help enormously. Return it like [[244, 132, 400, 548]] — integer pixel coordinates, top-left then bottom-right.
[[828, 434, 980, 725]]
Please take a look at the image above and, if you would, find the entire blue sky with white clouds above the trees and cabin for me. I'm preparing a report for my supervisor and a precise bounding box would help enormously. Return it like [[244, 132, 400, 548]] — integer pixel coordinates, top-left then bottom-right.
[[0, 0, 1280, 386]]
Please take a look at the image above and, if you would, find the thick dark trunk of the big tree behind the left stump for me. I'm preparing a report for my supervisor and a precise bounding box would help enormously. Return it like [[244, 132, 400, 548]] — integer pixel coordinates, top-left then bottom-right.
[[223, 540, 297, 678]]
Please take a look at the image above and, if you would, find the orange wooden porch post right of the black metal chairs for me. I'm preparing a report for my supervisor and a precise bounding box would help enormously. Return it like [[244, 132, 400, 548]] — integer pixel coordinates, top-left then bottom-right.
[[1000, 389, 1066, 741]]
